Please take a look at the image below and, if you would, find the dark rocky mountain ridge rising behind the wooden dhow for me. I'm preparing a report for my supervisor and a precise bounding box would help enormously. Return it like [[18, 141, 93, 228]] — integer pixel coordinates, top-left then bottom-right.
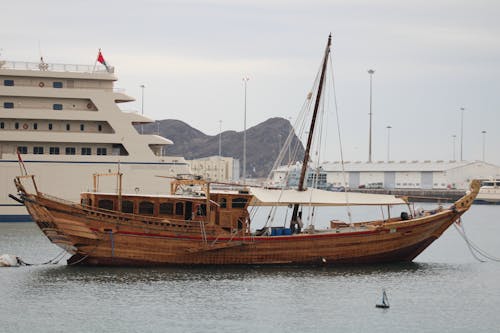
[[144, 118, 304, 178]]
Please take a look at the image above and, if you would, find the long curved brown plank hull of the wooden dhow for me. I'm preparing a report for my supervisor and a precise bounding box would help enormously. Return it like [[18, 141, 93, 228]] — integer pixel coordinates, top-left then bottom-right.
[[25, 194, 468, 266]]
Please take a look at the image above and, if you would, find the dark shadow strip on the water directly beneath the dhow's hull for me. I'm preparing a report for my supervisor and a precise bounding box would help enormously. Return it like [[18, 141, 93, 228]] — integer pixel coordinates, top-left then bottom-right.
[[30, 262, 463, 283]]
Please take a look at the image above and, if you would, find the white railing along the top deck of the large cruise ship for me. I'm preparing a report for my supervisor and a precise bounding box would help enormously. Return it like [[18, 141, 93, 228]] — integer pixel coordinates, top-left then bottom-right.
[[0, 60, 114, 74]]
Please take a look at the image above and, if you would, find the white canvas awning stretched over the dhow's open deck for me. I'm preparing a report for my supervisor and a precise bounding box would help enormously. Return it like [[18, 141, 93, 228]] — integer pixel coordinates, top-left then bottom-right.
[[250, 188, 406, 206]]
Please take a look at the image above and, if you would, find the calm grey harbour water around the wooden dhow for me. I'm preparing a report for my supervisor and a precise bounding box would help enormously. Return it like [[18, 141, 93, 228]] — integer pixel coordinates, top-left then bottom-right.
[[0, 206, 500, 332]]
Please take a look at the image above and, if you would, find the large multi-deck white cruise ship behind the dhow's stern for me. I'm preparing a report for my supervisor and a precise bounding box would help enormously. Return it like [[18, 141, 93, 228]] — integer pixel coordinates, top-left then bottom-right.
[[0, 60, 189, 222]]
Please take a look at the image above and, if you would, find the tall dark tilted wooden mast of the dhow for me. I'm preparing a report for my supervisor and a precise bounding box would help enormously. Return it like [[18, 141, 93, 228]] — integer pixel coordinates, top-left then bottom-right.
[[292, 34, 332, 224]]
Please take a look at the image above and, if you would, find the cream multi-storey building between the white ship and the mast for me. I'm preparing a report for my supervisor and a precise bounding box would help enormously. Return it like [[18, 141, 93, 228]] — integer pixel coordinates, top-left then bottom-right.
[[188, 156, 240, 182]]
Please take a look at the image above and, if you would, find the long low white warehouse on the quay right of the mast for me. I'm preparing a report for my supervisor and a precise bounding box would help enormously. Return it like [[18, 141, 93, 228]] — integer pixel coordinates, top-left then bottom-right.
[[321, 161, 500, 189]]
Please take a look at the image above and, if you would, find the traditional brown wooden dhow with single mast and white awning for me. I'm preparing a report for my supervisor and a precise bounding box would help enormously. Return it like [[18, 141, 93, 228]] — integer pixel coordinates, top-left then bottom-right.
[[14, 37, 479, 265]]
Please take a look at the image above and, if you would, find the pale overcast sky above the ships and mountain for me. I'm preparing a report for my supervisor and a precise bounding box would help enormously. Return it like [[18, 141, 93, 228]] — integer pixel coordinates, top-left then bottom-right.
[[0, 0, 500, 165]]
